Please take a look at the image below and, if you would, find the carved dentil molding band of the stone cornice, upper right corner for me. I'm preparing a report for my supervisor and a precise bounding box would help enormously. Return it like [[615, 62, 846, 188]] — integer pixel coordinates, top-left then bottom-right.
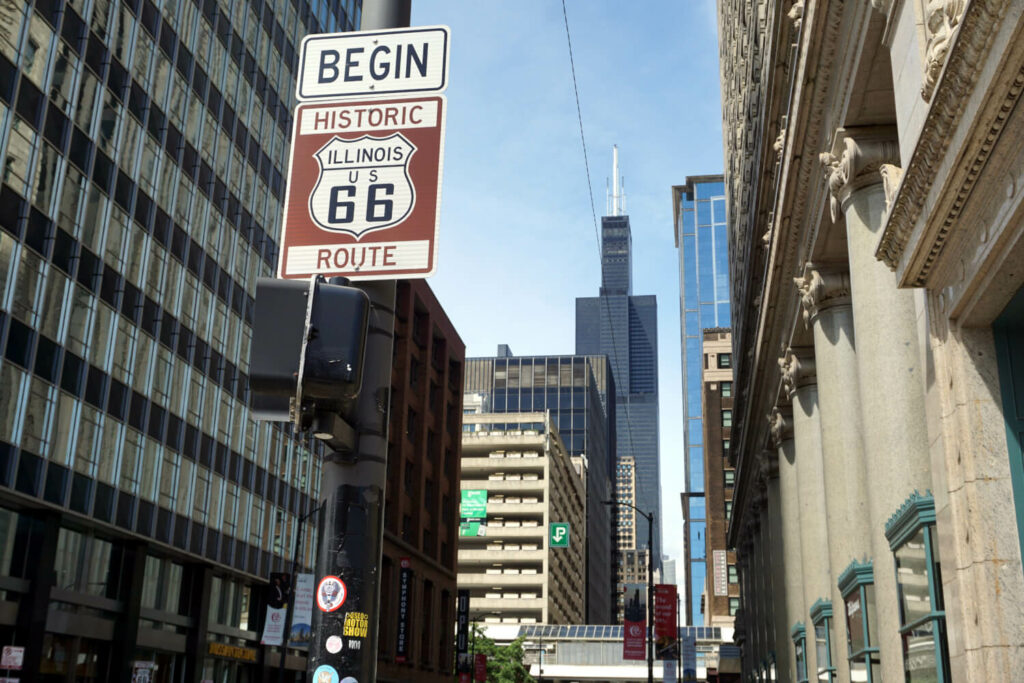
[[876, 0, 1024, 287]]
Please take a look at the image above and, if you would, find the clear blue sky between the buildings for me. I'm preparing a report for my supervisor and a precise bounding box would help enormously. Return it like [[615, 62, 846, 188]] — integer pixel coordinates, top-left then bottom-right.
[[412, 0, 723, 582]]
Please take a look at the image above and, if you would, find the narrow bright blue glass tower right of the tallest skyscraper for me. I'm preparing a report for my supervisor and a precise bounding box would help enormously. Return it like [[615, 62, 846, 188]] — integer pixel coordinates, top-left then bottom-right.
[[672, 175, 730, 626]]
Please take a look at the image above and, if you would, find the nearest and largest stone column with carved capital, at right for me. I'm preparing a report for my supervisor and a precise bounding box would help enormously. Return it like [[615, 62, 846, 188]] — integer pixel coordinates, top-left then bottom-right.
[[829, 129, 931, 680]]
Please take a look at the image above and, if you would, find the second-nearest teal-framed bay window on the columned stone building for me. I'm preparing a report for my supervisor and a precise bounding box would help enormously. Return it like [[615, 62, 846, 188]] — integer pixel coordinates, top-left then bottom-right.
[[839, 561, 882, 683]]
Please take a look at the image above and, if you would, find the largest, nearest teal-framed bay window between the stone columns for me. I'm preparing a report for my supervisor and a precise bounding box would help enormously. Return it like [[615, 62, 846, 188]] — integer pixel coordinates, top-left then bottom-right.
[[886, 493, 950, 683]]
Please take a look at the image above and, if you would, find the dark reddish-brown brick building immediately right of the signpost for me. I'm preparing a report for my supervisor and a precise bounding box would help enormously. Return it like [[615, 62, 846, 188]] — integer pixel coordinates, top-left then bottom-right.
[[377, 280, 466, 683]]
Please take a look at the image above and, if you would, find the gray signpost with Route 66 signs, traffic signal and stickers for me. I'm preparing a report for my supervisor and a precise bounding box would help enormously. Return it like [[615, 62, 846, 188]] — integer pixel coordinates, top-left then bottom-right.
[[253, 0, 449, 683]]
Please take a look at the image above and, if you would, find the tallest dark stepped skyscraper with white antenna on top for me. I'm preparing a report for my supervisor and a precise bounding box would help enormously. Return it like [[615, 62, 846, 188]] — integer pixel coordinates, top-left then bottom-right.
[[575, 166, 664, 602]]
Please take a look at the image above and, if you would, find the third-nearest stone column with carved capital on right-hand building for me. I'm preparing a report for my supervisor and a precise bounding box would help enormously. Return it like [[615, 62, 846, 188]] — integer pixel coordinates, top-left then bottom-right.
[[778, 348, 834, 672]]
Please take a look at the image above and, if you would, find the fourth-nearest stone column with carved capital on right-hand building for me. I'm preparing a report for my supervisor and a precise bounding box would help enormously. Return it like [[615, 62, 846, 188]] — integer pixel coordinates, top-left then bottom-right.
[[768, 405, 811, 681]]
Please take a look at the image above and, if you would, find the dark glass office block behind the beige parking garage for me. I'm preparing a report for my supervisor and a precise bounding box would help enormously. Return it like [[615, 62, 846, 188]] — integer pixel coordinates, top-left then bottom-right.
[[463, 352, 615, 624]]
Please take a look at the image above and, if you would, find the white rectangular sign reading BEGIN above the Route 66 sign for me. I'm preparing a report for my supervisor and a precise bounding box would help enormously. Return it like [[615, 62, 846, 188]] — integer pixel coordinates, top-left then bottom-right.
[[296, 26, 449, 101]]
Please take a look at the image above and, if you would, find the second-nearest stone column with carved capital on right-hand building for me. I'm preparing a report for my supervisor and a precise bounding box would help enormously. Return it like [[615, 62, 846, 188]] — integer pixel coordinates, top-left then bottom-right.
[[796, 263, 871, 680]]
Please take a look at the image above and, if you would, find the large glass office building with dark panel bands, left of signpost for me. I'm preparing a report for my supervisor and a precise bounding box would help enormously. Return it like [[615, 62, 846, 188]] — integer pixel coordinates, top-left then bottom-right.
[[0, 0, 360, 681]]
